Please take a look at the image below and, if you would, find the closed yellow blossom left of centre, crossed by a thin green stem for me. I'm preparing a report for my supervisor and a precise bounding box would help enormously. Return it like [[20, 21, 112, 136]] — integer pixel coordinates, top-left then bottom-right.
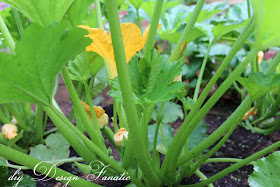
[[81, 101, 109, 129]]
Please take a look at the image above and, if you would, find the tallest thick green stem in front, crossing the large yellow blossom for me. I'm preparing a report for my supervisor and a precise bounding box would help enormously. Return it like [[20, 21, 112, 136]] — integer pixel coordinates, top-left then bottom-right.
[[105, 0, 161, 186]]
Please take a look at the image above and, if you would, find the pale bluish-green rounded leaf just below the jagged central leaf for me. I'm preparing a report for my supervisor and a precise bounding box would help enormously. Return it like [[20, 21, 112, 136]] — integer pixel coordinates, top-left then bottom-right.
[[152, 102, 184, 123]]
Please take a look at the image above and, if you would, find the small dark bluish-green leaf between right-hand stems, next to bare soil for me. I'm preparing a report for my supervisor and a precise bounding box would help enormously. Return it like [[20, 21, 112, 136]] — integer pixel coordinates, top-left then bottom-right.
[[188, 120, 208, 150]]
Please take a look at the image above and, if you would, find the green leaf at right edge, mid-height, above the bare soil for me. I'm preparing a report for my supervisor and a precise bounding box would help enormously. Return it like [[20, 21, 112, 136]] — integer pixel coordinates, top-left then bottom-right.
[[237, 72, 280, 101]]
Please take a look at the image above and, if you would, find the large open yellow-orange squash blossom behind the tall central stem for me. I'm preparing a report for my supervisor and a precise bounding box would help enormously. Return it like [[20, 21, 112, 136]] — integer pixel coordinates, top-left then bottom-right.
[[79, 23, 160, 79]]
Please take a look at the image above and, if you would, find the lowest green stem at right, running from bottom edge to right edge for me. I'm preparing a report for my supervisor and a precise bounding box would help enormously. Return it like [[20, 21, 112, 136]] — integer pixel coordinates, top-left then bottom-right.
[[180, 141, 280, 187]]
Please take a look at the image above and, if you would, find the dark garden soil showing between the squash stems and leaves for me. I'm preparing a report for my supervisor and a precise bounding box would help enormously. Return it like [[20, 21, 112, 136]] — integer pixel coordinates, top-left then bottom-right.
[[22, 99, 280, 187]]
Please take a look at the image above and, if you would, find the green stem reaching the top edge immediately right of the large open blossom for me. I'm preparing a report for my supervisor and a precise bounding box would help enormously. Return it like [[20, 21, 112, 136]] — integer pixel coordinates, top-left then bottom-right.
[[144, 0, 164, 59]]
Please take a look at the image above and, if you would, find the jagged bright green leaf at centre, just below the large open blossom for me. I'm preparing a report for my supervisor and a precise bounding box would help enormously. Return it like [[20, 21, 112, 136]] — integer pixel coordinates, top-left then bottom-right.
[[110, 50, 184, 106]]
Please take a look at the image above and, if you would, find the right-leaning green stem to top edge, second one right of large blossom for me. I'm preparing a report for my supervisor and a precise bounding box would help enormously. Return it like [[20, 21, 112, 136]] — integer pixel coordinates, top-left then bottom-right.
[[168, 0, 205, 62]]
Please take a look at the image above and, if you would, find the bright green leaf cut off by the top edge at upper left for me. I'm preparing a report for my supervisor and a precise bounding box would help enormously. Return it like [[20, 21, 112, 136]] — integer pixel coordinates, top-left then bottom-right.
[[2, 0, 74, 25]]
